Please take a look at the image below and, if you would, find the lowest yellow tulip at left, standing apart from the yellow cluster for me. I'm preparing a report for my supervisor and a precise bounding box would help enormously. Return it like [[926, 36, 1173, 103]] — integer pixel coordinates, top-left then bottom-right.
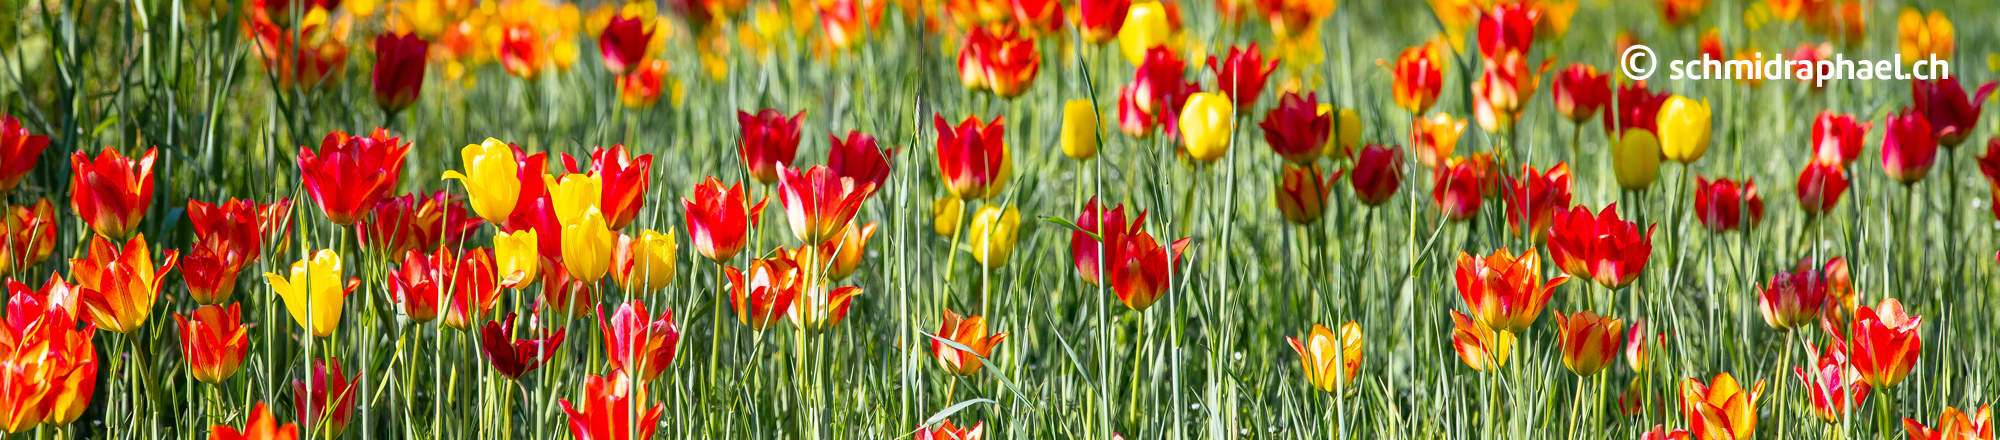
[[264, 250, 354, 338]]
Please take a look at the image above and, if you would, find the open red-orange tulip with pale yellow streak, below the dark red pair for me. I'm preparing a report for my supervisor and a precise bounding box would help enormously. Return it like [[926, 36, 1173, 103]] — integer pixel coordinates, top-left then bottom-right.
[[778, 166, 876, 242]]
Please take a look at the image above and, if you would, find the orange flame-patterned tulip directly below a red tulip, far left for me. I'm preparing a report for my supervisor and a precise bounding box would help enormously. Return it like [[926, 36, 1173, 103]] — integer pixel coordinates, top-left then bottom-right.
[[70, 234, 180, 334]]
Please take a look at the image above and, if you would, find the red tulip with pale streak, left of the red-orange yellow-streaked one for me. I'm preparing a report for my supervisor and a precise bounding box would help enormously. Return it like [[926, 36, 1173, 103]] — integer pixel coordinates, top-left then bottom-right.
[[680, 176, 770, 262]]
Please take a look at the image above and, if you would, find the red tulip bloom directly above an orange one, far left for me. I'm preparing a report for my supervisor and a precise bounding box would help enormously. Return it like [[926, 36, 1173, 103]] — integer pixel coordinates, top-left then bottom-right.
[[70, 148, 158, 240]]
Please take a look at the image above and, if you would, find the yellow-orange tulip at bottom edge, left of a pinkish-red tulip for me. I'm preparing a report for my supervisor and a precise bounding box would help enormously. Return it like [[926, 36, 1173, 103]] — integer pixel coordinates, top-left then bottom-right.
[[1680, 372, 1764, 440]]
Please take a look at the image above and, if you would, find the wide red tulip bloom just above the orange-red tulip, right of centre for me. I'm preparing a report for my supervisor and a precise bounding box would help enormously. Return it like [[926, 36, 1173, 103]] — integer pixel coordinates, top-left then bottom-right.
[[1548, 204, 1654, 288]]
